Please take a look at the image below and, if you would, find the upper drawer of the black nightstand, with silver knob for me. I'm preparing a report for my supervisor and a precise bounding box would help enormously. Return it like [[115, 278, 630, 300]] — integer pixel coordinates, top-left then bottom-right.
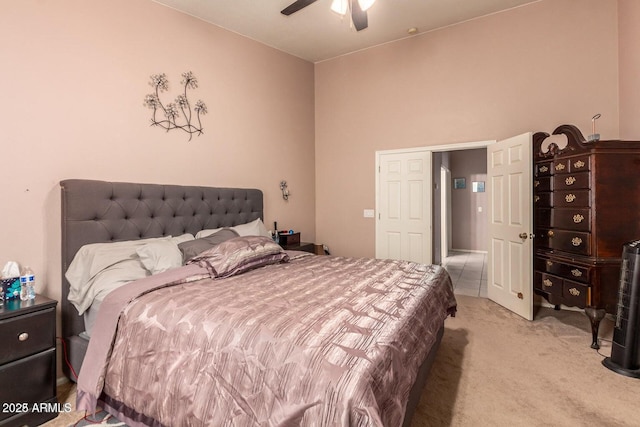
[[0, 308, 56, 364]]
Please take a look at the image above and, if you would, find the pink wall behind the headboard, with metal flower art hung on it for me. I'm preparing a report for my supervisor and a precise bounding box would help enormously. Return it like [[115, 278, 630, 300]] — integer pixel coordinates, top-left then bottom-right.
[[0, 0, 315, 376]]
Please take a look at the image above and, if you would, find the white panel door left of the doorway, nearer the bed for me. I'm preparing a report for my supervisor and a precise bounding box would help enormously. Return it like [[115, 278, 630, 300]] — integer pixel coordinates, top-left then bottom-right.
[[376, 151, 431, 264]]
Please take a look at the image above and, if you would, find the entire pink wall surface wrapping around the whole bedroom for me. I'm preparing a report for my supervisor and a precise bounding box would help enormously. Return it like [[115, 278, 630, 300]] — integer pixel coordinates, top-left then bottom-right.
[[5, 0, 640, 382]]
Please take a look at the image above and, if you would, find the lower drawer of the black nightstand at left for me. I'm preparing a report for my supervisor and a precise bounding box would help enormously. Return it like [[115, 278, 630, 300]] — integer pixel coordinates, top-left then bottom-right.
[[0, 348, 56, 425]]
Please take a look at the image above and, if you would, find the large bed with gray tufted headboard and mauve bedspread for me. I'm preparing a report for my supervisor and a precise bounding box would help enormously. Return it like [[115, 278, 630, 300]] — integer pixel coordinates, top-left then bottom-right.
[[60, 180, 456, 426]]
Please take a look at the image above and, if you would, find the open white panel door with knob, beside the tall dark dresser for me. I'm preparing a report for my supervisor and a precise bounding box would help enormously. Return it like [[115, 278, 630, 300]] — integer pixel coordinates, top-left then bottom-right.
[[487, 133, 533, 320]]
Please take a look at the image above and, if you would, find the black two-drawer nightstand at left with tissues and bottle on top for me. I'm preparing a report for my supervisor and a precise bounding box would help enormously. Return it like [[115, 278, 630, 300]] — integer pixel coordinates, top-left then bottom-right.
[[0, 295, 59, 427]]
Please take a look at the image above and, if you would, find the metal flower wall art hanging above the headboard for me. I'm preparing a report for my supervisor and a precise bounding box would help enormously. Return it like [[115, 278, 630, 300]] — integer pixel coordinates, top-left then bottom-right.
[[144, 71, 207, 141]]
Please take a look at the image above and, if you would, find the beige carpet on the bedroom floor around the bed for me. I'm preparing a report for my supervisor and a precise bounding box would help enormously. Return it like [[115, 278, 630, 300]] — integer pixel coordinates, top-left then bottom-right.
[[45, 295, 640, 427]]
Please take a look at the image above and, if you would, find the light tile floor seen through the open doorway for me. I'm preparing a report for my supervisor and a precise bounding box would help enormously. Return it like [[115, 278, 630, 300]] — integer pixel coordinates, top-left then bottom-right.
[[442, 251, 487, 298]]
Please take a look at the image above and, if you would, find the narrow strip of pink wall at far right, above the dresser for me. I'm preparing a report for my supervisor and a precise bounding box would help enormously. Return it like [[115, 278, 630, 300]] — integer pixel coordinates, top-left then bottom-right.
[[618, 0, 640, 140]]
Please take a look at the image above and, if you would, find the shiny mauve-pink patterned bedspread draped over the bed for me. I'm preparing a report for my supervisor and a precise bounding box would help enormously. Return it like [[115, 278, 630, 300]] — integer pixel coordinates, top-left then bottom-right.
[[78, 254, 456, 426]]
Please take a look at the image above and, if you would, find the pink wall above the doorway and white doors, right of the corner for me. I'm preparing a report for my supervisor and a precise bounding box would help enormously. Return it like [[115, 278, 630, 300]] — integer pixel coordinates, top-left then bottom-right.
[[315, 0, 624, 256]]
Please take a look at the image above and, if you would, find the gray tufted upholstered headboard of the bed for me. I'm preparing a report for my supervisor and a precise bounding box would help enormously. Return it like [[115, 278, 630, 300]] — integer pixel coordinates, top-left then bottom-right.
[[60, 179, 264, 378]]
